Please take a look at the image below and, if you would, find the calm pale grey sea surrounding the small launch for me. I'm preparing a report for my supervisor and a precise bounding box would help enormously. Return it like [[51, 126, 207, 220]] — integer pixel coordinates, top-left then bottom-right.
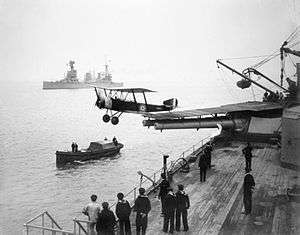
[[0, 80, 223, 234]]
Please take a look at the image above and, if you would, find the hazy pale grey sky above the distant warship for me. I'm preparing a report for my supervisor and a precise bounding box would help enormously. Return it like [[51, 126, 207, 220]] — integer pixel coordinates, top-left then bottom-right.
[[0, 0, 300, 89]]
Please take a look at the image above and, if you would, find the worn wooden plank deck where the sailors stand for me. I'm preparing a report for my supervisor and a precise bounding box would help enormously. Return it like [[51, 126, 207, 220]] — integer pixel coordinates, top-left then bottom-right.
[[131, 143, 297, 234]]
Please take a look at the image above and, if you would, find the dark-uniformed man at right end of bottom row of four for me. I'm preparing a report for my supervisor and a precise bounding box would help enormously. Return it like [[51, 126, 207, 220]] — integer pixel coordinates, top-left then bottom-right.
[[134, 188, 151, 235]]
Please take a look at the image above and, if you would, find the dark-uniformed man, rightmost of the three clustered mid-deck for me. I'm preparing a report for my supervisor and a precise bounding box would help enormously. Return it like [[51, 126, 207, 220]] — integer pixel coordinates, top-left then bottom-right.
[[175, 184, 190, 231]]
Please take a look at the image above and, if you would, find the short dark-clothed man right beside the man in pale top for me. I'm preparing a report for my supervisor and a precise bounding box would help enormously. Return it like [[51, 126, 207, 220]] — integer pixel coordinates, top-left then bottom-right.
[[96, 202, 116, 235]]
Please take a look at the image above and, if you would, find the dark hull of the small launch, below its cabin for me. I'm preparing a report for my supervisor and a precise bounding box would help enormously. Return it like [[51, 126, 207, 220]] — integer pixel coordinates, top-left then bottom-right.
[[56, 143, 123, 165]]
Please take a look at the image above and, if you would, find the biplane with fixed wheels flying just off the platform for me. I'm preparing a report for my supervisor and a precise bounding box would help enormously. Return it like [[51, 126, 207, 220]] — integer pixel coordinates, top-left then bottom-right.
[[94, 87, 178, 125]]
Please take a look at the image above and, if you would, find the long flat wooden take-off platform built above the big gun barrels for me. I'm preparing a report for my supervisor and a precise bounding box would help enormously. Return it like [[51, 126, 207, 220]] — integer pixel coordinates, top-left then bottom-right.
[[143, 101, 282, 120]]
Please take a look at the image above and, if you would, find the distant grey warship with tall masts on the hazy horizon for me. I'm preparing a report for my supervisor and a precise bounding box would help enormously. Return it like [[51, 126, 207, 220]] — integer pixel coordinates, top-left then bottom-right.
[[43, 60, 123, 90]]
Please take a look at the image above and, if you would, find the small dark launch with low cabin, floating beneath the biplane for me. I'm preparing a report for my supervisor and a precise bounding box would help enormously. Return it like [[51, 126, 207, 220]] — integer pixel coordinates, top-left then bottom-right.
[[56, 141, 124, 165]]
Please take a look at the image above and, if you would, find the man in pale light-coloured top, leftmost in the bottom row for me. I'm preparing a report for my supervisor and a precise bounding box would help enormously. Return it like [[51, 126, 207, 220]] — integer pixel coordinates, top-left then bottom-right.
[[82, 194, 100, 235]]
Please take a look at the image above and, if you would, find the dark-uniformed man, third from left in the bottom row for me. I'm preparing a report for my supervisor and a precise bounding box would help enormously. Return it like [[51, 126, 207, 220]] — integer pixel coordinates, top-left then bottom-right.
[[116, 193, 131, 235]]
